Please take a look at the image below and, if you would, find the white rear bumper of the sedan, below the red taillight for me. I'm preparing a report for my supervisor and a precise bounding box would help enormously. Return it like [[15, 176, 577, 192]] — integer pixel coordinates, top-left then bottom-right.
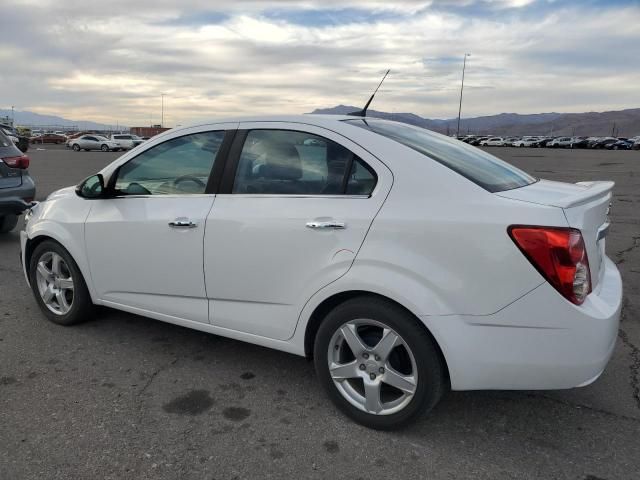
[[423, 257, 622, 390]]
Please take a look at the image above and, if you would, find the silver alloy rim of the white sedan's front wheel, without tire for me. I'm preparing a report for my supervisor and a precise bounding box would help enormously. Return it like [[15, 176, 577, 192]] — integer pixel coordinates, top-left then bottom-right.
[[36, 252, 74, 315]]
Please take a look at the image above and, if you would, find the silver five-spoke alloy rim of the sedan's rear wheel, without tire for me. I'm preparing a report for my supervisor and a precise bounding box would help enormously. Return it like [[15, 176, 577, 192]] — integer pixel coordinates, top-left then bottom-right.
[[327, 319, 418, 415]]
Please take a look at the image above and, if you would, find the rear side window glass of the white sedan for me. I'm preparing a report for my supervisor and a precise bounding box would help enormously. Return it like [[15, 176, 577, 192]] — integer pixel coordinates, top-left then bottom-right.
[[233, 130, 377, 195]]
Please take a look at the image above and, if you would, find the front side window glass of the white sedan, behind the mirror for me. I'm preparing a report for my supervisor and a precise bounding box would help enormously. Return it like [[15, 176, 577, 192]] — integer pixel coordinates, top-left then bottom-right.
[[115, 131, 224, 195]]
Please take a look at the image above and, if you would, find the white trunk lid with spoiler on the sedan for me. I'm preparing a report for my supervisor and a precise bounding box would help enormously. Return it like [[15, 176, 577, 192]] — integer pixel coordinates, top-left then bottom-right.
[[496, 180, 615, 288]]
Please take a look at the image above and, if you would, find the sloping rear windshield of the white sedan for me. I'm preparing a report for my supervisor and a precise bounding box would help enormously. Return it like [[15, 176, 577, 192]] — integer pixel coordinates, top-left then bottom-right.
[[345, 118, 536, 192]]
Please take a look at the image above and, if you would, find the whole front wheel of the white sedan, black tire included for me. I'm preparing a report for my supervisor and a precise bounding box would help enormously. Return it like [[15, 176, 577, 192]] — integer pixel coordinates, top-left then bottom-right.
[[29, 240, 94, 326]]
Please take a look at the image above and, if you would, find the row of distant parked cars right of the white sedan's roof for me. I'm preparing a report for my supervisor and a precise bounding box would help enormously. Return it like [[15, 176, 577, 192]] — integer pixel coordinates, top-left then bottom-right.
[[461, 135, 640, 150]]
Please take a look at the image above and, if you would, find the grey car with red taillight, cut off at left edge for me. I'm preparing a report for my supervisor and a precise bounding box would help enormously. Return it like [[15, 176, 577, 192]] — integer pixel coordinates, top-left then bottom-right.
[[0, 129, 36, 233]]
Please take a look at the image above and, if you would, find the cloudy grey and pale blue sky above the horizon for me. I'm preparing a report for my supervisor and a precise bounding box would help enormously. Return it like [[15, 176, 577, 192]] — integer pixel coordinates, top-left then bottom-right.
[[0, 0, 640, 126]]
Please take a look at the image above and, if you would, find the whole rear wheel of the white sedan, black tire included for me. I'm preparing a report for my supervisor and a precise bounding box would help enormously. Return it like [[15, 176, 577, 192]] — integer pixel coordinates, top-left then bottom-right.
[[314, 296, 448, 430]]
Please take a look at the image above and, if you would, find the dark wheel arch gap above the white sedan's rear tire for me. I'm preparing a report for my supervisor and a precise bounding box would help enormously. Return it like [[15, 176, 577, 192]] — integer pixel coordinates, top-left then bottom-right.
[[304, 290, 451, 385]]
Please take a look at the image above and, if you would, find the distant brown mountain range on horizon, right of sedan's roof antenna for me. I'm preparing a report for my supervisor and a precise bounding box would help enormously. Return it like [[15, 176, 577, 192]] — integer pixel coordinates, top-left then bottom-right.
[[311, 105, 640, 137]]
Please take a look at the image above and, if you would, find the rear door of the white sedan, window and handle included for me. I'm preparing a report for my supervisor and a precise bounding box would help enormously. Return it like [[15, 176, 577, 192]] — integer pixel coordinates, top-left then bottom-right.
[[204, 122, 392, 340]]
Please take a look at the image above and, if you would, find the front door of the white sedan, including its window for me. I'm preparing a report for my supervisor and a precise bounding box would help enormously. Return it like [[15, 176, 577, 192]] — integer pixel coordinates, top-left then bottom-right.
[[85, 127, 230, 322]]
